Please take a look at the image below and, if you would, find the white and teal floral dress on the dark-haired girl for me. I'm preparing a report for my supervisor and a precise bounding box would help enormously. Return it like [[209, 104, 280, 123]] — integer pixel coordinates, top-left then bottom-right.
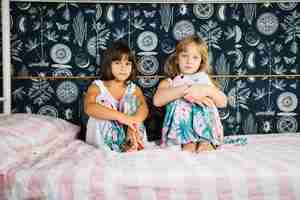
[[86, 80, 146, 152]]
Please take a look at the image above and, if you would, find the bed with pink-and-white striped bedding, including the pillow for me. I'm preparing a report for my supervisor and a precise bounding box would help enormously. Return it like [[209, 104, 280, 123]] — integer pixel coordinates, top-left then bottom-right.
[[0, 114, 300, 200]]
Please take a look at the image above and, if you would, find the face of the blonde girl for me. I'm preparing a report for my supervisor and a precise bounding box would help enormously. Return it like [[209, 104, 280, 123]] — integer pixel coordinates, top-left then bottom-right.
[[178, 43, 202, 74]]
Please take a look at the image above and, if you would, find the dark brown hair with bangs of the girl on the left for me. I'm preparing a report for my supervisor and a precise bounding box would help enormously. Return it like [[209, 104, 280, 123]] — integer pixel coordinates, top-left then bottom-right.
[[101, 41, 137, 81]]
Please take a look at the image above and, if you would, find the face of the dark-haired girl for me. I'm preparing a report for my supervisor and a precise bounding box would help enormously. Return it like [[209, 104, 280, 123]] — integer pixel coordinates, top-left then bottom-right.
[[111, 54, 132, 81]]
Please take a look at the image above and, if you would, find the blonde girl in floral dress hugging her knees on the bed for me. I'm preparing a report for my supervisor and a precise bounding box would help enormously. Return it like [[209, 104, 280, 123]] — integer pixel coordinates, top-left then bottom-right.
[[153, 36, 227, 152]]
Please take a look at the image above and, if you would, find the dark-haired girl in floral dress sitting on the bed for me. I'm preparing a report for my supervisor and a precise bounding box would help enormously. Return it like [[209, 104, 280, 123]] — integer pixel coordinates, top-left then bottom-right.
[[84, 42, 148, 152]]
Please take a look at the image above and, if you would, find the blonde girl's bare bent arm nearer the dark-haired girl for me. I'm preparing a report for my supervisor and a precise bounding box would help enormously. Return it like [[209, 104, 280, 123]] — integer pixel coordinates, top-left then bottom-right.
[[153, 79, 188, 107]]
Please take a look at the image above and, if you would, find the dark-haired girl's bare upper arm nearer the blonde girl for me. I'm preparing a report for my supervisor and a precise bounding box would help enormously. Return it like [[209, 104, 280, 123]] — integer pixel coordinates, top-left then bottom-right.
[[133, 87, 149, 123]]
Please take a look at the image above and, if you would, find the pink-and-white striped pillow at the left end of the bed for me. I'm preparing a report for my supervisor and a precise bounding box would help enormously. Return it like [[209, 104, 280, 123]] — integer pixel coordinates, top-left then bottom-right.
[[0, 113, 80, 153]]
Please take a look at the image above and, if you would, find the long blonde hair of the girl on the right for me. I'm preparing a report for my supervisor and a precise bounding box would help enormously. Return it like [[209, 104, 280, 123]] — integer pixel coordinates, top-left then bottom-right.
[[166, 35, 212, 78]]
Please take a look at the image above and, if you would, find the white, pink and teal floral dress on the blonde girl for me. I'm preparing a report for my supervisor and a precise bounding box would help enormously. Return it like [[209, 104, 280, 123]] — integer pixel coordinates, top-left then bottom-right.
[[161, 72, 223, 147]]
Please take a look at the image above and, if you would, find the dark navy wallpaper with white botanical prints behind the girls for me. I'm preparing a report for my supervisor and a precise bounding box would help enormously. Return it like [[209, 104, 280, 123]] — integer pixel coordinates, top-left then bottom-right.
[[4, 2, 300, 139]]
